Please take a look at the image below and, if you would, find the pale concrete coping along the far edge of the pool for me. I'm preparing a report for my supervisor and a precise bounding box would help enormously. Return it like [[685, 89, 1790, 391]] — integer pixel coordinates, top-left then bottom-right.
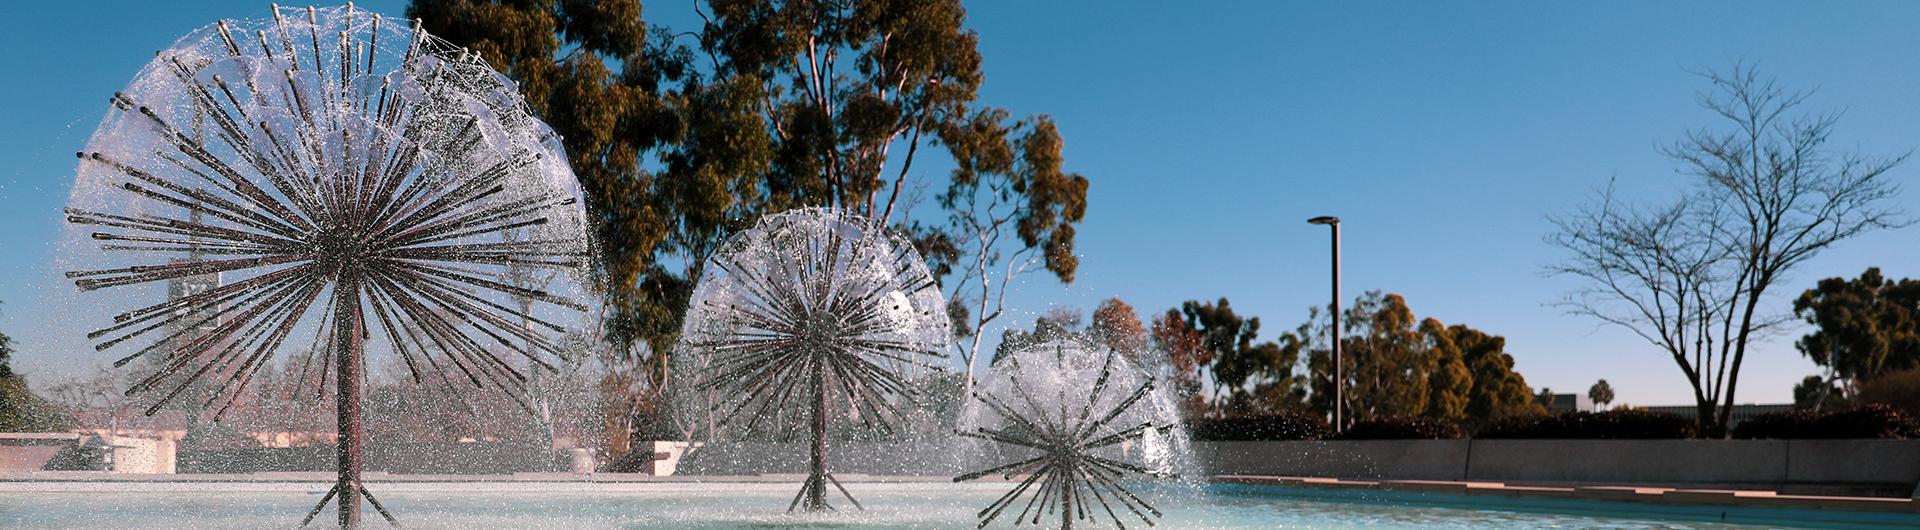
[[0, 470, 1920, 513]]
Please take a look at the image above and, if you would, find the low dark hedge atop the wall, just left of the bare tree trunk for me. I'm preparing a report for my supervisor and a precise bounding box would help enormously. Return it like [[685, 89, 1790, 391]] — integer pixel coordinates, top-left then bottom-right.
[[1475, 409, 1699, 440]]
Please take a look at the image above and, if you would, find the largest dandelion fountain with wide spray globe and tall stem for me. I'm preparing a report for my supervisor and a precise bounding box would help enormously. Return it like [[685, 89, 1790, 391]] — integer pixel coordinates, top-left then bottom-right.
[[65, 4, 588, 526]]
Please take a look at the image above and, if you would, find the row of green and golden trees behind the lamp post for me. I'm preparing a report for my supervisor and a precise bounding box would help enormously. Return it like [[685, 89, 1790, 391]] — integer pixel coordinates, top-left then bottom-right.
[[1148, 292, 1546, 426]]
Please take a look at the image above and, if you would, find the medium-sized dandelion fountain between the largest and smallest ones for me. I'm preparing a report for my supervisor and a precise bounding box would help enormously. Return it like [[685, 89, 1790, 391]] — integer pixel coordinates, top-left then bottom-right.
[[674, 209, 948, 511]]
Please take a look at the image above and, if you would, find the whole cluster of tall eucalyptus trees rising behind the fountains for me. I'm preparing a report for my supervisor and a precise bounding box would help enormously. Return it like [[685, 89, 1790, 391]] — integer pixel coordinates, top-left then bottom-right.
[[407, 0, 1089, 393]]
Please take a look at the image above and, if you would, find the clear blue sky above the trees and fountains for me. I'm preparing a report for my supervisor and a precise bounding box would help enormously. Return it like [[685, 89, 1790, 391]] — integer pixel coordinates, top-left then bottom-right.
[[0, 2, 1920, 405]]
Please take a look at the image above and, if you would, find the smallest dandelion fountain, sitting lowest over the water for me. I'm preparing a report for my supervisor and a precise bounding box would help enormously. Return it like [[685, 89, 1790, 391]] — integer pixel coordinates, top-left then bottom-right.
[[954, 336, 1187, 528]]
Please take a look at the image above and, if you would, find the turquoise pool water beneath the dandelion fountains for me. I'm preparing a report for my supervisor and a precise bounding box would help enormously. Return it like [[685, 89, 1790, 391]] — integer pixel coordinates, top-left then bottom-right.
[[0, 482, 1910, 530]]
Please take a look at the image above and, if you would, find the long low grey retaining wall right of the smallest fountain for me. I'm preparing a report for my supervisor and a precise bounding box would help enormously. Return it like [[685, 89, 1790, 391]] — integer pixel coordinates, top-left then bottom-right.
[[1194, 440, 1920, 495]]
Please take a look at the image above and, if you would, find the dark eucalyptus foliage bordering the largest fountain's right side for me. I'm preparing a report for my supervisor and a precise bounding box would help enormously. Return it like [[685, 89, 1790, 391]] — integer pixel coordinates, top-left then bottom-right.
[[407, 0, 695, 355]]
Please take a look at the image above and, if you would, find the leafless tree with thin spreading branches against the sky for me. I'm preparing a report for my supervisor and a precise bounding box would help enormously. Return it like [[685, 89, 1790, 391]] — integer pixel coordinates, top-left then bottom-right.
[[1548, 61, 1910, 436]]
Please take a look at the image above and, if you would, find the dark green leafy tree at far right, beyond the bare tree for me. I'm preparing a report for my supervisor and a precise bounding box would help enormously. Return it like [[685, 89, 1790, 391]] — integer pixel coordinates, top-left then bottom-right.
[[1793, 267, 1920, 380]]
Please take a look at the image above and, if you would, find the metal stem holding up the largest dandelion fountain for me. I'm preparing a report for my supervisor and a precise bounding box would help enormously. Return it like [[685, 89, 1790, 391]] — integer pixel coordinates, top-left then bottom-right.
[[334, 271, 365, 528]]
